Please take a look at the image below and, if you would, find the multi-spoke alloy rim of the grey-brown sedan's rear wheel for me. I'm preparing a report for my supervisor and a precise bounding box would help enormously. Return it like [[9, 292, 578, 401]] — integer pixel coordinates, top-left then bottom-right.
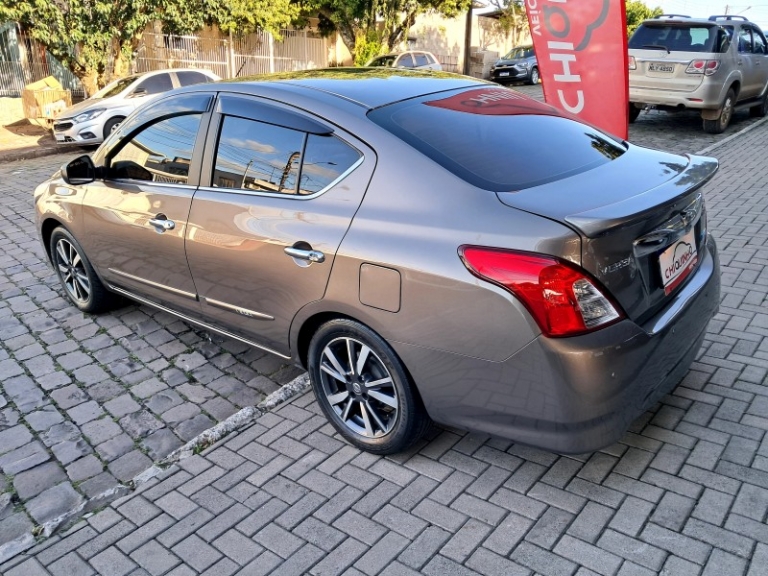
[[320, 337, 399, 438]]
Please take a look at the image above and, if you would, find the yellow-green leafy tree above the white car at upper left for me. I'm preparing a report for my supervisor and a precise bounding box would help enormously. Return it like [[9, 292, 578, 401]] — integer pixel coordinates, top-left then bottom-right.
[[0, 0, 298, 94]]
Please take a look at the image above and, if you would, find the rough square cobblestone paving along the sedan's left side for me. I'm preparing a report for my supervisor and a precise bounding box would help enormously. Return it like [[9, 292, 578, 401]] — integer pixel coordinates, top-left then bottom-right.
[[0, 155, 301, 558]]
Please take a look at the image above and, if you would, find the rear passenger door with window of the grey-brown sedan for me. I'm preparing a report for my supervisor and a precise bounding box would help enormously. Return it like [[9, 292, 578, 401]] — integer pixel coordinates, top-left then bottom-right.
[[186, 95, 375, 355]]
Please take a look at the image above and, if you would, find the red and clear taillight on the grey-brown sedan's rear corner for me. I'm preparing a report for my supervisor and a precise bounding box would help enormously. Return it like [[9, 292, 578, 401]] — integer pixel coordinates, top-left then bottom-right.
[[459, 246, 623, 337]]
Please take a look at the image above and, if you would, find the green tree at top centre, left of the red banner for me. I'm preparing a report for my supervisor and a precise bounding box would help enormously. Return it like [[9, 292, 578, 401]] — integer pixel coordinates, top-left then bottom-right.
[[302, 0, 471, 64]]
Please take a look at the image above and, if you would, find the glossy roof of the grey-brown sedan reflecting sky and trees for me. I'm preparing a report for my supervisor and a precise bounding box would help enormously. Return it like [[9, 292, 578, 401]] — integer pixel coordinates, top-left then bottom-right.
[[213, 68, 484, 109]]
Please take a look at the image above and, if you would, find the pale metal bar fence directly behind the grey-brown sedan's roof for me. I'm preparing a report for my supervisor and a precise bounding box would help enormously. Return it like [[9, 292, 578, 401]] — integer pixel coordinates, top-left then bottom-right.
[[134, 30, 328, 78]]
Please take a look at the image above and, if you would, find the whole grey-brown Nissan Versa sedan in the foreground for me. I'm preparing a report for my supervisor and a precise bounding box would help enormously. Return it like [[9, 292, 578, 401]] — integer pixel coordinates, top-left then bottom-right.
[[34, 69, 720, 454]]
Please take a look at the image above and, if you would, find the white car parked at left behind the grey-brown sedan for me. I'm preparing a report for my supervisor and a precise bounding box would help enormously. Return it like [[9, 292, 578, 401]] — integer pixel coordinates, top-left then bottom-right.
[[53, 69, 220, 146]]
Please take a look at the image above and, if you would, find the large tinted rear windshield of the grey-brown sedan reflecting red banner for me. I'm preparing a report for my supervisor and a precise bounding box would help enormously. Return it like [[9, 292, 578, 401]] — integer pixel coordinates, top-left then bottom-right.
[[368, 87, 626, 192]]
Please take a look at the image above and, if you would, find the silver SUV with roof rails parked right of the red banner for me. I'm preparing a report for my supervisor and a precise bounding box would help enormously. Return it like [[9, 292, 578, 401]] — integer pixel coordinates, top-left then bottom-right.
[[629, 14, 768, 134]]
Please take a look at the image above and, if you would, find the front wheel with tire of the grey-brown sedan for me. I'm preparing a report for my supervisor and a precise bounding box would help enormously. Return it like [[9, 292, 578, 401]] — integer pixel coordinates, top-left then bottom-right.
[[49, 226, 120, 314]]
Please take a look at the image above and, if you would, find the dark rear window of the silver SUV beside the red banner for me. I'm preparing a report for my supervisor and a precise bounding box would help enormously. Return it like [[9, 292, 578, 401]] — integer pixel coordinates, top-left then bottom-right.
[[629, 22, 733, 52]]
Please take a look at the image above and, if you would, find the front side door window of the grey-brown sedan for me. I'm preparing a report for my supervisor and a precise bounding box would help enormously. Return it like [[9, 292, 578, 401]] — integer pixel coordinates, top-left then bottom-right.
[[107, 114, 203, 184]]
